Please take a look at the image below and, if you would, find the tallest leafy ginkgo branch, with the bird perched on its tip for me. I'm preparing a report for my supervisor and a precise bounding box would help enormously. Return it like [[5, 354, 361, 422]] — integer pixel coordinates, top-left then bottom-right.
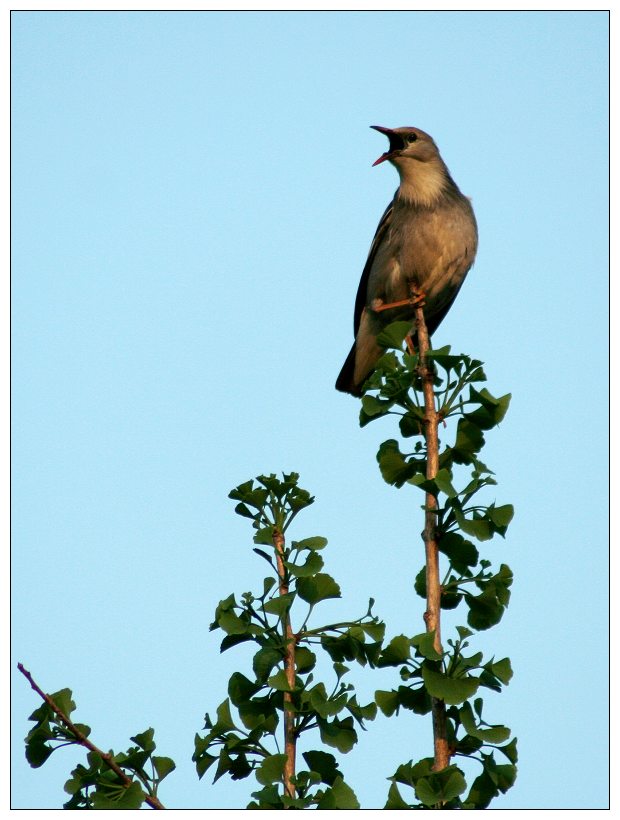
[[360, 305, 517, 808]]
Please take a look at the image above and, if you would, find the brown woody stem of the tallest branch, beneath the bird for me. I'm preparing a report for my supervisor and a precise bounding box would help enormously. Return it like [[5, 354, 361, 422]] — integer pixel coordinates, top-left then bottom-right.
[[415, 304, 450, 771]]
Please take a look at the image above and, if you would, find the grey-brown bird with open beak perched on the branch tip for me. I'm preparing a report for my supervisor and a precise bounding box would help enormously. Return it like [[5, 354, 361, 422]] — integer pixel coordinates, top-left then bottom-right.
[[336, 125, 478, 396]]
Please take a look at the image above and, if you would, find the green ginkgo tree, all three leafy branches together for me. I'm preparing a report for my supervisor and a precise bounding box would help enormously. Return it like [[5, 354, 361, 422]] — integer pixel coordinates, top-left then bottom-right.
[[19, 306, 517, 809]]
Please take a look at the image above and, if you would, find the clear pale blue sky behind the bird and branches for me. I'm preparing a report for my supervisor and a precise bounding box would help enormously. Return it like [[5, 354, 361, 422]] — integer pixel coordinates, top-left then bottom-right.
[[12, 12, 608, 809]]
